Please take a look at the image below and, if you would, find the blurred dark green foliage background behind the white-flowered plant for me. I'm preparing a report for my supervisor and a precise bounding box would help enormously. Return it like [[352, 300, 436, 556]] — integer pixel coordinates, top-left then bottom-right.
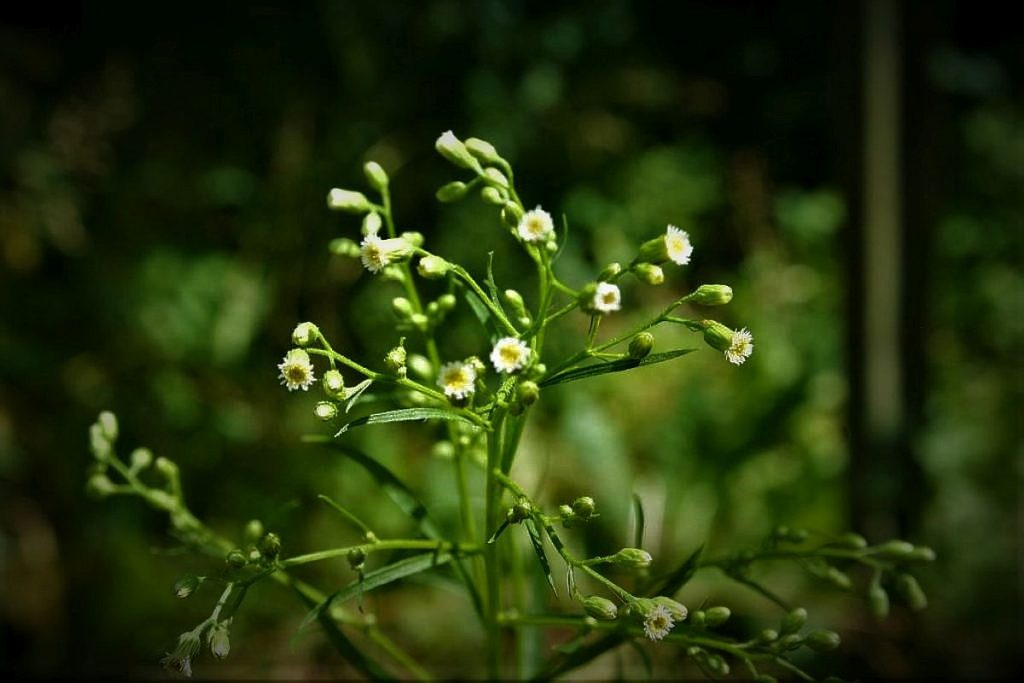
[[0, 0, 1024, 680]]
